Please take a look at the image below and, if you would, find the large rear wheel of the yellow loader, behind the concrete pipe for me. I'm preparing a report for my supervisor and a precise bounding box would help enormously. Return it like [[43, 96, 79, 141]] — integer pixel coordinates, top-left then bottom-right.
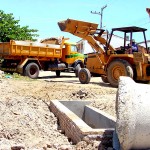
[[107, 59, 133, 87]]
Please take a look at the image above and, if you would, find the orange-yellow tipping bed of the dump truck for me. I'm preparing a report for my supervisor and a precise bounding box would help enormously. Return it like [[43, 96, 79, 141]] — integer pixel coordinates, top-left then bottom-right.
[[0, 41, 62, 58]]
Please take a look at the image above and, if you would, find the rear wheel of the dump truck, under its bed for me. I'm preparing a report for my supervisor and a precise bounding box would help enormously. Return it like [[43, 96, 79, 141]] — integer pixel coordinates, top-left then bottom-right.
[[25, 63, 39, 79]]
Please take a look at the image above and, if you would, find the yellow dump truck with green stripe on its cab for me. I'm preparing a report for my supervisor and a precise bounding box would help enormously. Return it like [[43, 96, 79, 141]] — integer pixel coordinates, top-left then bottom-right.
[[0, 38, 84, 79]]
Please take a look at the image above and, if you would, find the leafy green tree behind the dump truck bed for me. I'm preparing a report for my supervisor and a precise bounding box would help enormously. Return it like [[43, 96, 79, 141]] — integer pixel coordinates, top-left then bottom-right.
[[0, 10, 39, 42]]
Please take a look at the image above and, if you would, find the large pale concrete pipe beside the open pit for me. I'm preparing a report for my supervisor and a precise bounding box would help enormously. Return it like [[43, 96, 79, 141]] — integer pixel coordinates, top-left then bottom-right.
[[116, 77, 150, 150]]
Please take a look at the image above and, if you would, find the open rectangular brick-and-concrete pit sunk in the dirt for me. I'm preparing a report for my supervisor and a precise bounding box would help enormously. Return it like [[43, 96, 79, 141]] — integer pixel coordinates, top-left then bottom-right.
[[50, 100, 116, 146]]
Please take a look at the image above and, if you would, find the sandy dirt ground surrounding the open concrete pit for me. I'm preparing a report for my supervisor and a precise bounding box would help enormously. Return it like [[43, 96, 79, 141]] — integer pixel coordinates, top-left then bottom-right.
[[0, 72, 117, 150]]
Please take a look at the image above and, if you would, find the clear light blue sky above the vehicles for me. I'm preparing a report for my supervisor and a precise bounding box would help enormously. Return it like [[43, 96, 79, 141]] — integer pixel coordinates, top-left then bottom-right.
[[0, 0, 150, 42]]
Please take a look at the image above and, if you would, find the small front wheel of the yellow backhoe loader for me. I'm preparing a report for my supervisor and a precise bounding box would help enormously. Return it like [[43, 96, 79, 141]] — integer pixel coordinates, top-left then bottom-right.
[[79, 68, 91, 84]]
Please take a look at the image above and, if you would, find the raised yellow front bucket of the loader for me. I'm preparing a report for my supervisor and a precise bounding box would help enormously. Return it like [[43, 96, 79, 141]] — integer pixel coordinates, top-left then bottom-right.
[[58, 19, 98, 38]]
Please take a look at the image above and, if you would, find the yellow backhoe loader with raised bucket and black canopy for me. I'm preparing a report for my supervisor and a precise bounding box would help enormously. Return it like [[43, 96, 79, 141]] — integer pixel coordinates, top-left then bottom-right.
[[58, 19, 150, 87]]
